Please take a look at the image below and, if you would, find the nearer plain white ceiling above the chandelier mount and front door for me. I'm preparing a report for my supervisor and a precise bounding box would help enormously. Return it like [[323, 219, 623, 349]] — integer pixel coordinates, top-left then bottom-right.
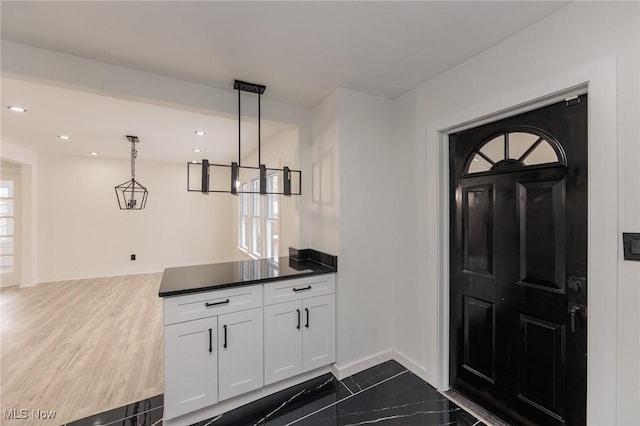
[[0, 1, 568, 107]]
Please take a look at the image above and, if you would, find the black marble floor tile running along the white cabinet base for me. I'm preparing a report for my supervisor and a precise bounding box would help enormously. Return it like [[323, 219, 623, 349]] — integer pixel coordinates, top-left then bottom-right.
[[197, 374, 351, 426]]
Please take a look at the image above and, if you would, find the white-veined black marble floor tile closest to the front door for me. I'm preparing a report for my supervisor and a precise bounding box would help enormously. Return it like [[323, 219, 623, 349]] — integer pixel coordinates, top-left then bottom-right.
[[293, 372, 477, 426]]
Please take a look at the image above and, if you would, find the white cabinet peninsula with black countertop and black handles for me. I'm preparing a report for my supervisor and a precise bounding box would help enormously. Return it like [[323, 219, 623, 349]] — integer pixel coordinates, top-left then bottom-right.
[[159, 249, 337, 425]]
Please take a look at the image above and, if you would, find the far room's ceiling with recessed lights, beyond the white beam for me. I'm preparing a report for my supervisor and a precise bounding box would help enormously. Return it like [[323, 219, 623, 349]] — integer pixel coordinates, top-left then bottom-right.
[[2, 78, 285, 164]]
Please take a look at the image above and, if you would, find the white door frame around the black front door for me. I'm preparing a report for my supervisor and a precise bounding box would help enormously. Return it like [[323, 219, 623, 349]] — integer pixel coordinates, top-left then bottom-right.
[[427, 55, 619, 425]]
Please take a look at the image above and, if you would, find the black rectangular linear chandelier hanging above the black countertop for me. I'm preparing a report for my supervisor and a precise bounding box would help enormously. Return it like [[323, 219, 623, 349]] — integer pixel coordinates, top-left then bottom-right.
[[187, 80, 302, 196]]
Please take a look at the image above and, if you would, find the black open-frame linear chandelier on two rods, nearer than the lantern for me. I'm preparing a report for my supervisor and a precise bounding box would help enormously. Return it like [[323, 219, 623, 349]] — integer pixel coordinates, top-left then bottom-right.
[[187, 80, 302, 196]]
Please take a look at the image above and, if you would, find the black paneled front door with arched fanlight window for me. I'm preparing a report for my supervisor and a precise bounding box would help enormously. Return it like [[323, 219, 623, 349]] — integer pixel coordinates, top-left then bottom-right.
[[450, 95, 587, 425]]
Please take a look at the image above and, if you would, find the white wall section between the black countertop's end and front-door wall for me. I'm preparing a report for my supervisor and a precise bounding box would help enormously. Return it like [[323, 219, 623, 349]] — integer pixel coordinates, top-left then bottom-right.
[[311, 89, 402, 376]]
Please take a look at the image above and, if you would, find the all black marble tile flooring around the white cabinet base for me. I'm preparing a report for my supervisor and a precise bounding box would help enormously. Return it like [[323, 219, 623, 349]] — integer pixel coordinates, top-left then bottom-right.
[[69, 361, 486, 426]]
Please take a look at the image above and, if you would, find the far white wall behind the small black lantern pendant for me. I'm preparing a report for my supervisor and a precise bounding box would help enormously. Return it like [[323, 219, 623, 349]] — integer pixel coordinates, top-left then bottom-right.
[[37, 152, 236, 282]]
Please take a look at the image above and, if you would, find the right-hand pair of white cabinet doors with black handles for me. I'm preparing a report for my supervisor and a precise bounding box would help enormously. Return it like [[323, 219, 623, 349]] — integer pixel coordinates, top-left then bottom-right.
[[264, 294, 335, 385]]
